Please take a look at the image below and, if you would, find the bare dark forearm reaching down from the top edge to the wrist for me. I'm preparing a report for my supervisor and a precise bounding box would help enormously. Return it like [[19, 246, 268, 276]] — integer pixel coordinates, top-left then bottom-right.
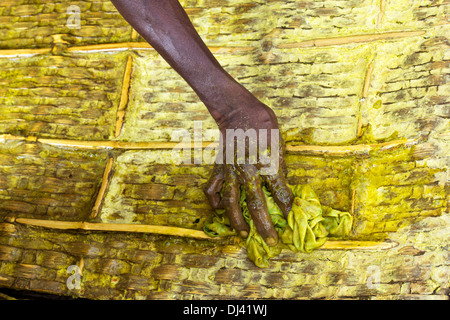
[[107, 0, 251, 123]]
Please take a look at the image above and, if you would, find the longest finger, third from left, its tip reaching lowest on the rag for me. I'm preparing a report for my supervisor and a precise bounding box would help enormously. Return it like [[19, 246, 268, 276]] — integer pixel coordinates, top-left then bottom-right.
[[240, 165, 278, 246]]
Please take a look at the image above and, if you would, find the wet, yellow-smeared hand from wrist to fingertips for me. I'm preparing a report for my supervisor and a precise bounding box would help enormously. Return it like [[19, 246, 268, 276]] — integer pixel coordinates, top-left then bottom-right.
[[205, 96, 294, 246]]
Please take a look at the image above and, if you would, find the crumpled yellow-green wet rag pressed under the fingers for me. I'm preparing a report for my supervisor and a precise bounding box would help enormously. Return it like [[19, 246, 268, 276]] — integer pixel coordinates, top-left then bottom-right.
[[203, 185, 353, 268]]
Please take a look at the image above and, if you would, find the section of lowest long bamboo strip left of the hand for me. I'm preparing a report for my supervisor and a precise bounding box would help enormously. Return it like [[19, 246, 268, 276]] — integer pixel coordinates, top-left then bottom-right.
[[16, 218, 213, 239]]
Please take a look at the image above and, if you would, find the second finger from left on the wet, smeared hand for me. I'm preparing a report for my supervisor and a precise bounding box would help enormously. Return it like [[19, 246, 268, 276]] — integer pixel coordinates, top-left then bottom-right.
[[222, 166, 250, 238]]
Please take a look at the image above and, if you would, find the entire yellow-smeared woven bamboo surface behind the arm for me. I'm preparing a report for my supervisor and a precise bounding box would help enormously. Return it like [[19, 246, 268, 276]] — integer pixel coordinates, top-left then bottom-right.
[[0, 0, 450, 299]]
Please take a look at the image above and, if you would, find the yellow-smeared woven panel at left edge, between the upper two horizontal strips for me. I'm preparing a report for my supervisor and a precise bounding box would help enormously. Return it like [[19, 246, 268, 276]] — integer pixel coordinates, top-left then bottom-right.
[[0, 50, 126, 140]]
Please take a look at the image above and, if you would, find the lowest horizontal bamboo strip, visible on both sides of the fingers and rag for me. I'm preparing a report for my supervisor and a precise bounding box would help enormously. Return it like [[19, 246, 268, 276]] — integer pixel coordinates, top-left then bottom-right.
[[16, 218, 397, 250]]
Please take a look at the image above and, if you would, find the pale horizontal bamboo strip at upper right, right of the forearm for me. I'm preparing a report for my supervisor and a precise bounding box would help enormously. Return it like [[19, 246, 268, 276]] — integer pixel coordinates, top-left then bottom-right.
[[277, 30, 426, 49]]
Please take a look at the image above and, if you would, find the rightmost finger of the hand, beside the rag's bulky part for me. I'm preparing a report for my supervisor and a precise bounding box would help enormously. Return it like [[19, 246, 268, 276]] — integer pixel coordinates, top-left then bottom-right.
[[264, 172, 294, 217]]
